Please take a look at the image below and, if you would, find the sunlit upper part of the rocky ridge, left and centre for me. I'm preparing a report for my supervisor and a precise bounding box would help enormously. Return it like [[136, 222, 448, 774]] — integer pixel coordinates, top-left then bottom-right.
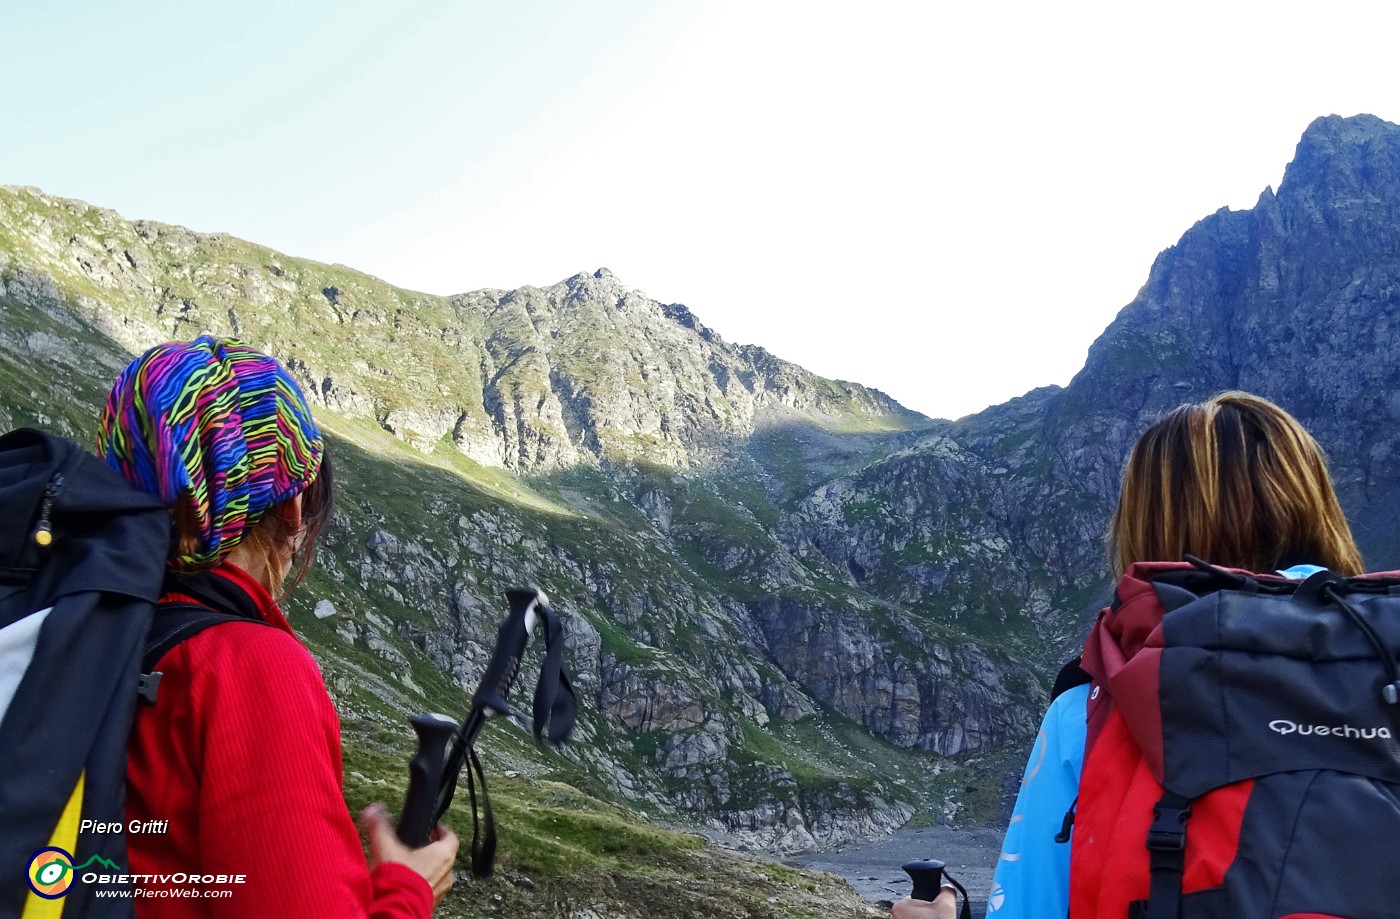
[[0, 189, 928, 472]]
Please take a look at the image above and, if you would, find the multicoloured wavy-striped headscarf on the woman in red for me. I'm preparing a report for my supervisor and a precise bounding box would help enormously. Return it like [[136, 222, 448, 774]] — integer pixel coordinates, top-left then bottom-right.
[[97, 335, 325, 569]]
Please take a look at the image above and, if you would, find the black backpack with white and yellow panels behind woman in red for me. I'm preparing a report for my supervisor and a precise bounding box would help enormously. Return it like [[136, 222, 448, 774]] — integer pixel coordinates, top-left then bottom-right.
[[0, 430, 171, 919]]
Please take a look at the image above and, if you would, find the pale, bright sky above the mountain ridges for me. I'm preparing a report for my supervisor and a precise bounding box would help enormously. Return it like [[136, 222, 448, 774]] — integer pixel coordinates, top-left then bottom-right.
[[0, 0, 1400, 417]]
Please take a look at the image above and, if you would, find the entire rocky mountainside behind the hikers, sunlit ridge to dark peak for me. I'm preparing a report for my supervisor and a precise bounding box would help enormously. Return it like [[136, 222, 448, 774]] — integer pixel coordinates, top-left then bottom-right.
[[0, 118, 1400, 849]]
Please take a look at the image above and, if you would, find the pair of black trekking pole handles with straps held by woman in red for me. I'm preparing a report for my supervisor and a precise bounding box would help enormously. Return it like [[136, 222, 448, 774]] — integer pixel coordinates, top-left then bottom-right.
[[398, 590, 574, 877]]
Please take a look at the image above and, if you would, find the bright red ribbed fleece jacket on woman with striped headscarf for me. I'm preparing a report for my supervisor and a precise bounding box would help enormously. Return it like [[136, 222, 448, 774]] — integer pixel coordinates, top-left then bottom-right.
[[126, 565, 433, 919]]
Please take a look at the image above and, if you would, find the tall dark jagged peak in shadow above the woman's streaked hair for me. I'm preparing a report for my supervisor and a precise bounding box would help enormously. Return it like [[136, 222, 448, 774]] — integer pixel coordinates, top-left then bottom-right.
[[1067, 116, 1400, 566]]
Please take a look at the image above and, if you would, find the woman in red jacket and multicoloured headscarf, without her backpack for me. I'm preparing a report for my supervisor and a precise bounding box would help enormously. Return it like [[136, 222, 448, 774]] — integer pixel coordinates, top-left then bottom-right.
[[98, 336, 458, 919]]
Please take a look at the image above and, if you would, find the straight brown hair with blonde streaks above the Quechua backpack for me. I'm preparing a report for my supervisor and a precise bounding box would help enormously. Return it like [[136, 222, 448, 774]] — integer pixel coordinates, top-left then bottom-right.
[[1109, 392, 1362, 577]]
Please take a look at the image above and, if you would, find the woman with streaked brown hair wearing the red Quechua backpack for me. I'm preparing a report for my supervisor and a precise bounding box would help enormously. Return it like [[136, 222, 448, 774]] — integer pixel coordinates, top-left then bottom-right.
[[997, 391, 1377, 919]]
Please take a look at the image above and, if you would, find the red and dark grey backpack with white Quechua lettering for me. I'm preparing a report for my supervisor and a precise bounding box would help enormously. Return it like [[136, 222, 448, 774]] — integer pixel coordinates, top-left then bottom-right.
[[1070, 560, 1400, 919]]
